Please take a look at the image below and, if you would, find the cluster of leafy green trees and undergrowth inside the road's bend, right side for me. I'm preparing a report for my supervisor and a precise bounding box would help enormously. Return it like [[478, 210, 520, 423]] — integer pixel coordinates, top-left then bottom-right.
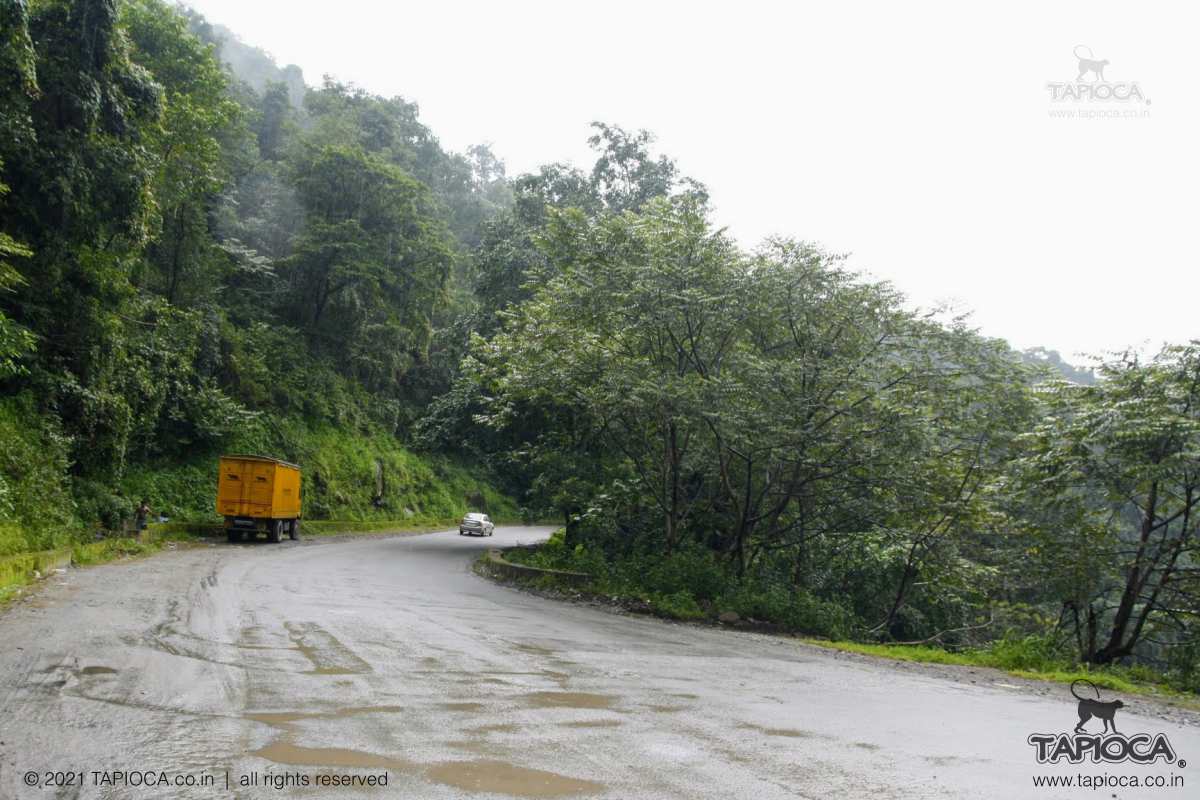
[[451, 195, 1200, 691]]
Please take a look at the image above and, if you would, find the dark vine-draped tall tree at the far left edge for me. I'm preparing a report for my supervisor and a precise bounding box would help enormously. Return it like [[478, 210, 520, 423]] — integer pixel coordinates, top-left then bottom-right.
[[0, 0, 162, 470]]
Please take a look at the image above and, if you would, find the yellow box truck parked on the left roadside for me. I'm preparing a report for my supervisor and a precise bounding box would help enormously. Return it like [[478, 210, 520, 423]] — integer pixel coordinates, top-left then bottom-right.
[[217, 456, 300, 542]]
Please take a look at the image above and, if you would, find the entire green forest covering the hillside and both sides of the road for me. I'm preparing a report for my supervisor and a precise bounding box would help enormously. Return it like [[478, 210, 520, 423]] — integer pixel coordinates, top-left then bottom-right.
[[0, 0, 1200, 688]]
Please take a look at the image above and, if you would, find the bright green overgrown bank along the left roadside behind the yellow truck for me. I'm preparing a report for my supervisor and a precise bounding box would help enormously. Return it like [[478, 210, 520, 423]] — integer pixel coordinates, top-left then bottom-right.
[[0, 396, 517, 593]]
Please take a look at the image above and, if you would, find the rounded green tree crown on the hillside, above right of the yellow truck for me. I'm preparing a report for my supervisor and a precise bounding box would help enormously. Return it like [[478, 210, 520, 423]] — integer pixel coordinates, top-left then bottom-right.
[[283, 145, 452, 387]]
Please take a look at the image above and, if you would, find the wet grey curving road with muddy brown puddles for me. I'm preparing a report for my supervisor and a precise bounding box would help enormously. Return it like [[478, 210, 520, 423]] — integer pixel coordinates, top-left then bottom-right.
[[0, 528, 1200, 799]]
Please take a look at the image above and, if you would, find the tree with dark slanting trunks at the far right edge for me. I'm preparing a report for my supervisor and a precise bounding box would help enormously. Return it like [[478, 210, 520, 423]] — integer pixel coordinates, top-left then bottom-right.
[[1022, 343, 1200, 663]]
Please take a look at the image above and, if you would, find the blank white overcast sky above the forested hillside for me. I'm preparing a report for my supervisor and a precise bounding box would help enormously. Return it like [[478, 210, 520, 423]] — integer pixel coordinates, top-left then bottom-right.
[[188, 0, 1200, 356]]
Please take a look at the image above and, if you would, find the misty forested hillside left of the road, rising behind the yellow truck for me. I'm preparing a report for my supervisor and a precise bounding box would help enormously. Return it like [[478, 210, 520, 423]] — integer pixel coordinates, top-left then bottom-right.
[[0, 0, 517, 558]]
